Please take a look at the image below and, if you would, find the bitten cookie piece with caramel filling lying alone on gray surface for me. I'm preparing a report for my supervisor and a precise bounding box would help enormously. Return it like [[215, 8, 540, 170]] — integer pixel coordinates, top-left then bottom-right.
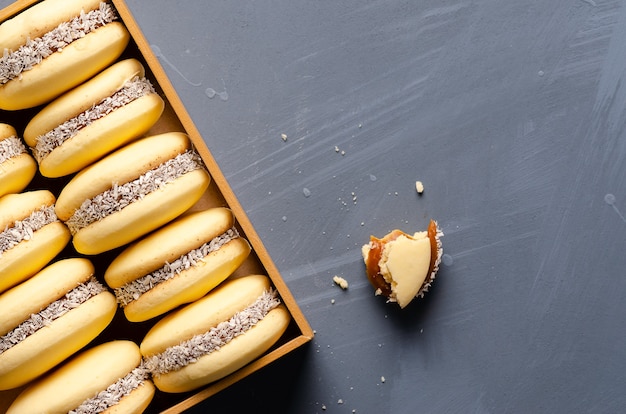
[[361, 220, 443, 308]]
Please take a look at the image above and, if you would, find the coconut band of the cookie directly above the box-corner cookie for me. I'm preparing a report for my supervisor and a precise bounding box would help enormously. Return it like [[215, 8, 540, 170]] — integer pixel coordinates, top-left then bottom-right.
[[114, 227, 239, 307]]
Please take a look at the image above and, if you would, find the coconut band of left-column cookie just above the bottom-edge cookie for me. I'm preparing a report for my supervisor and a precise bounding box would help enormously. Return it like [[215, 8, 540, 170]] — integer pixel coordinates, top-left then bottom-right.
[[0, 276, 106, 354]]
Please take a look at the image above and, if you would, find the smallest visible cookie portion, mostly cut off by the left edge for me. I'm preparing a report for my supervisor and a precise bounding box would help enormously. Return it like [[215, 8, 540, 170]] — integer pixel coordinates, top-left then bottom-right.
[[0, 123, 37, 197]]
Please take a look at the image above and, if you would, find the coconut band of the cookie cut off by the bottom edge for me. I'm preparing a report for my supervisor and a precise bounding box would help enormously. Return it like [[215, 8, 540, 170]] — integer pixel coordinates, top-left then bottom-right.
[[68, 363, 150, 414]]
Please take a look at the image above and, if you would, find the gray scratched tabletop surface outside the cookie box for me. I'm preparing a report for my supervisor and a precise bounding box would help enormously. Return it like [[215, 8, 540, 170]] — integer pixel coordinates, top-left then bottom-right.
[[2, 0, 626, 413]]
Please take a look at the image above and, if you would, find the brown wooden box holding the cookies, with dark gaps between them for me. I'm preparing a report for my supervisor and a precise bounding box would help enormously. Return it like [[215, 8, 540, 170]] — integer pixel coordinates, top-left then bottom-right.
[[0, 0, 313, 413]]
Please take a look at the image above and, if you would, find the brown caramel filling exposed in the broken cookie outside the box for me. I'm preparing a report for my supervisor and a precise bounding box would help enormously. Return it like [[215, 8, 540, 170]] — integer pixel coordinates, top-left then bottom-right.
[[365, 220, 439, 297]]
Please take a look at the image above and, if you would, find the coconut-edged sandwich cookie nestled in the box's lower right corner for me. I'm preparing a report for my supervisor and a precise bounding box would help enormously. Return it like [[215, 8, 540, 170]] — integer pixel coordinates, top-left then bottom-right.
[[140, 275, 290, 392]]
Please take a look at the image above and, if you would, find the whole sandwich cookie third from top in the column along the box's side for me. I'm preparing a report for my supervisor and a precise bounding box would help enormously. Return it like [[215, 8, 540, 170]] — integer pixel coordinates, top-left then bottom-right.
[[55, 132, 211, 255]]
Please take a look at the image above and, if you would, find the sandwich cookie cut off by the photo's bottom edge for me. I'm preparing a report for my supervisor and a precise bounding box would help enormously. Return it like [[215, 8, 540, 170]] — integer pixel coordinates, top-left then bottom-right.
[[7, 340, 155, 414]]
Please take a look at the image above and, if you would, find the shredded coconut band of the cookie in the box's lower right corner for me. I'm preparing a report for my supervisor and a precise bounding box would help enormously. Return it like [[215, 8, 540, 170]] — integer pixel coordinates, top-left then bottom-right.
[[144, 289, 280, 375]]
